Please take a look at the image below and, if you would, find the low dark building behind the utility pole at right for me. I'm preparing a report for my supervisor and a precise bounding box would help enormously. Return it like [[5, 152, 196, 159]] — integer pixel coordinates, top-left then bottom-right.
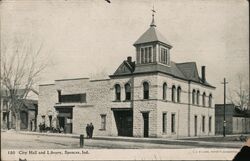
[[215, 104, 250, 135]]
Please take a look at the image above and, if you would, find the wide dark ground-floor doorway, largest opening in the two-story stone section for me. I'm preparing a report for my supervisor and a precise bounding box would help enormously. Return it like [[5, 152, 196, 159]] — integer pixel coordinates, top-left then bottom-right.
[[114, 110, 133, 136]]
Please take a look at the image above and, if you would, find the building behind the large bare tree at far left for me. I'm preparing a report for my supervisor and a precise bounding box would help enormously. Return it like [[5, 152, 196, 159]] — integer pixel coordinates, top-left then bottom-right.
[[0, 89, 38, 131]]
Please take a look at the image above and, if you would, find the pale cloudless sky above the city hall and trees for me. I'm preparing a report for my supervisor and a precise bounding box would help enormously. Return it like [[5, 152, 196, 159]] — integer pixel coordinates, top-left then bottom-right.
[[1, 0, 249, 103]]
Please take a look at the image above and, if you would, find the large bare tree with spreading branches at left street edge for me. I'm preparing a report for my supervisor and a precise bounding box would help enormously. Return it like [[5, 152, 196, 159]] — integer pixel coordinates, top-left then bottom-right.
[[1, 38, 47, 130]]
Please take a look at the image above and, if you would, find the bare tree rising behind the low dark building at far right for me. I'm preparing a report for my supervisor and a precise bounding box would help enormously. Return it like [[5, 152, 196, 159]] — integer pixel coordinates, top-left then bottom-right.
[[228, 74, 249, 110]]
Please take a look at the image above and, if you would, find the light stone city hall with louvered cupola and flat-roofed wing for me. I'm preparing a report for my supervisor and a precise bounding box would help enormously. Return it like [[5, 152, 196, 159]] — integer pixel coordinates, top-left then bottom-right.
[[38, 17, 215, 137]]
